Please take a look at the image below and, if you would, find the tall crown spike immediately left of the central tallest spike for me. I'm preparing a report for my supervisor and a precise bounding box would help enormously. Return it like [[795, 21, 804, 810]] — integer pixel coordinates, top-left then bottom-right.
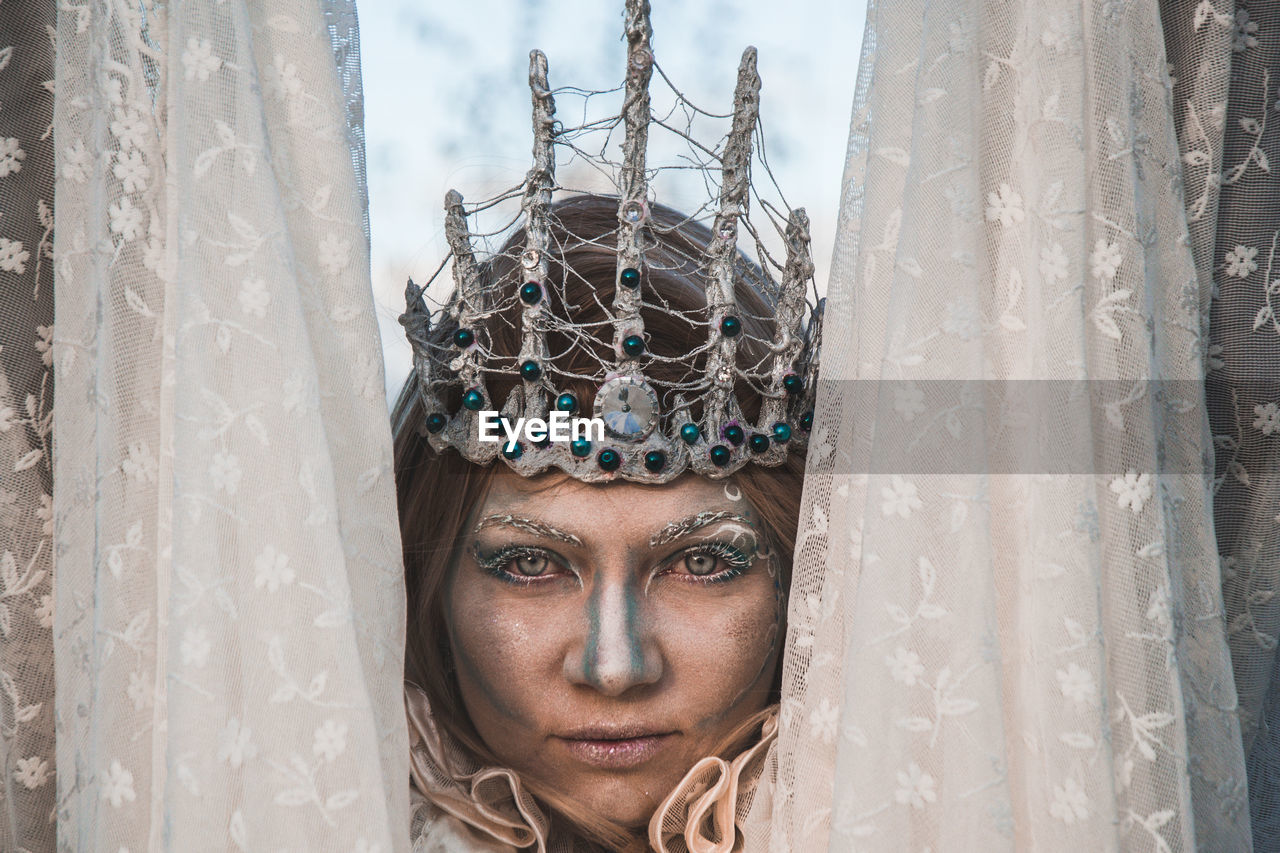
[[518, 50, 556, 416]]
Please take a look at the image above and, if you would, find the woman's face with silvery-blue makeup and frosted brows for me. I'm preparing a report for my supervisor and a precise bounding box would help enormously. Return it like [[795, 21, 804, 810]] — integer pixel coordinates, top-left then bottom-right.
[[445, 470, 783, 826]]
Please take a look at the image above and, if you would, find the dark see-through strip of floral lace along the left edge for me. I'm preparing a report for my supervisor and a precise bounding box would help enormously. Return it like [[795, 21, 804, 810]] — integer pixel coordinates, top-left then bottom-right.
[[0, 0, 58, 852]]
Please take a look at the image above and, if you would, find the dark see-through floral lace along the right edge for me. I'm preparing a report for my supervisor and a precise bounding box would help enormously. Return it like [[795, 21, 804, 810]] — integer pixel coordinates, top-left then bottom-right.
[[1162, 3, 1280, 852]]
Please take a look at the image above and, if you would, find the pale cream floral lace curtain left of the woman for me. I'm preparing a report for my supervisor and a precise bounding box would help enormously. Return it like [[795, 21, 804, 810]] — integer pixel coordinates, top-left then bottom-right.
[[49, 0, 408, 853]]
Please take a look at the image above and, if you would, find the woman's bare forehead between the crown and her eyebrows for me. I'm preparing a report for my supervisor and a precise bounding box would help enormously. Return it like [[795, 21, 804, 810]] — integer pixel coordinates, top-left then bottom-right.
[[472, 467, 751, 535]]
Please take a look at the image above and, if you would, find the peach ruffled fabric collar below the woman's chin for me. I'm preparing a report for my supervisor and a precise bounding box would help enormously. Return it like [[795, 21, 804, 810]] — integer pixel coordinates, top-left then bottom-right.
[[404, 684, 778, 853]]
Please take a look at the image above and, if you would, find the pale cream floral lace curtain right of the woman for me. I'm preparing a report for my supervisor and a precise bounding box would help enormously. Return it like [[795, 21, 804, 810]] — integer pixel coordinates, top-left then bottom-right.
[[748, 0, 1251, 850]]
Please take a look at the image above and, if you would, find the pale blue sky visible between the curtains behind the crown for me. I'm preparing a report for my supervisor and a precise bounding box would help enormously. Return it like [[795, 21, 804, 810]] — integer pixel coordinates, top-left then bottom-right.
[[360, 0, 865, 398]]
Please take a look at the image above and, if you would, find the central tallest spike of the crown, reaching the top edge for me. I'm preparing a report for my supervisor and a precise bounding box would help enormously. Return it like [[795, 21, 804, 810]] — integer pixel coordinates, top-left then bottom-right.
[[613, 0, 653, 373]]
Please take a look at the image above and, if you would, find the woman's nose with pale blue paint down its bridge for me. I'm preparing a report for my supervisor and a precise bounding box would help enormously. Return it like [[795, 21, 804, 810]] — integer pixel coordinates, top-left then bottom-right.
[[564, 576, 663, 697]]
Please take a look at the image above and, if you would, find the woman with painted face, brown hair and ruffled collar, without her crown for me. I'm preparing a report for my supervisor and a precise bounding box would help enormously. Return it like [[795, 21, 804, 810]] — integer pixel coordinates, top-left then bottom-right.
[[394, 196, 804, 850]]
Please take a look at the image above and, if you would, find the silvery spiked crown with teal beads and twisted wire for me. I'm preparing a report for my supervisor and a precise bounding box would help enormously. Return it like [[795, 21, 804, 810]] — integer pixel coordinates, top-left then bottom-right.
[[399, 0, 824, 483]]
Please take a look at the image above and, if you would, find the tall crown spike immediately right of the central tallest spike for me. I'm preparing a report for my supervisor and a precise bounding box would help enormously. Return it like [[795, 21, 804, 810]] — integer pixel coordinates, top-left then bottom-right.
[[704, 47, 760, 445]]
